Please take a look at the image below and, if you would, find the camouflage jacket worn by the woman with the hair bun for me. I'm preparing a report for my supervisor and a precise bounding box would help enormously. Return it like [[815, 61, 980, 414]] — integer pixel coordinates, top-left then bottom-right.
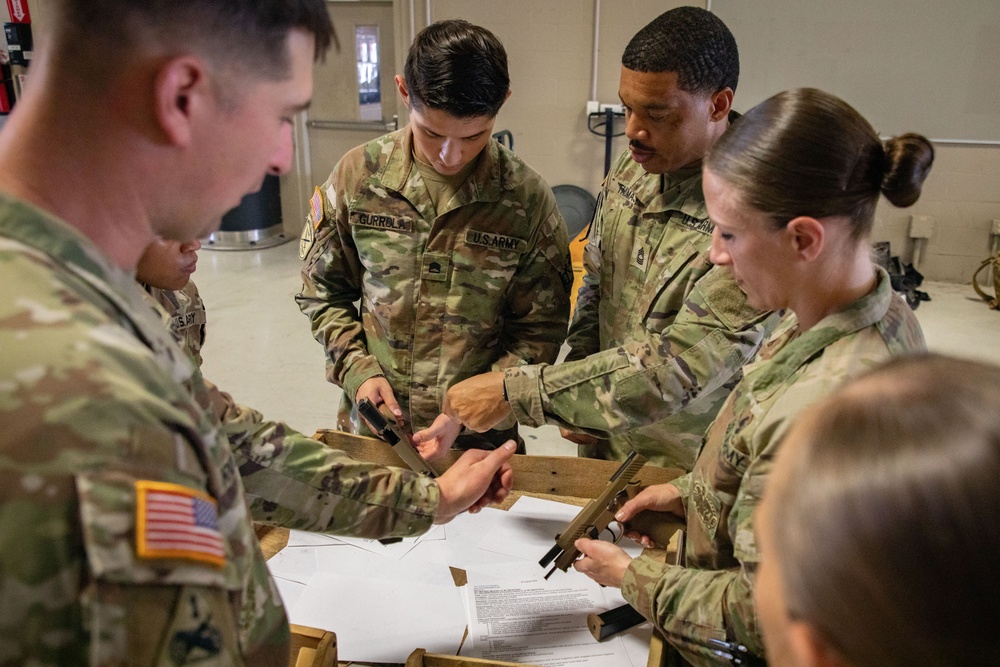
[[622, 269, 924, 665]]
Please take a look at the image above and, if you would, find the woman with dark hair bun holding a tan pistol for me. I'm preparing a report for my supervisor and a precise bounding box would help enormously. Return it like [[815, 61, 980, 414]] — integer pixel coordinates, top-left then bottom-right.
[[575, 89, 934, 665]]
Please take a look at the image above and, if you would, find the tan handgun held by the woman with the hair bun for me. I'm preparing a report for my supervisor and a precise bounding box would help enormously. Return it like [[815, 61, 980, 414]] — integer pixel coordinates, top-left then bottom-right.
[[538, 451, 684, 579]]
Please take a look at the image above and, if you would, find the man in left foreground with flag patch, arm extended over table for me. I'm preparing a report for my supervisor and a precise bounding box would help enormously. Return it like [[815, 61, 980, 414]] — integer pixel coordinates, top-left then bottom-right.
[[0, 0, 512, 665]]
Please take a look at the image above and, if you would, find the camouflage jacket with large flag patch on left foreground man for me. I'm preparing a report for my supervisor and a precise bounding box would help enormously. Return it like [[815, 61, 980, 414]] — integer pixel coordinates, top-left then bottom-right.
[[0, 197, 438, 665]]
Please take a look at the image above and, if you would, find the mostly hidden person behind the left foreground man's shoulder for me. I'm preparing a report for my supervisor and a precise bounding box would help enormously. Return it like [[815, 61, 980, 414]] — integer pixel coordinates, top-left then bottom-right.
[[135, 239, 207, 368]]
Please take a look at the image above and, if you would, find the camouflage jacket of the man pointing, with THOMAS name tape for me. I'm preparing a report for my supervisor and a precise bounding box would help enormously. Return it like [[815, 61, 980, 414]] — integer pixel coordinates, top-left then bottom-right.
[[506, 152, 777, 470]]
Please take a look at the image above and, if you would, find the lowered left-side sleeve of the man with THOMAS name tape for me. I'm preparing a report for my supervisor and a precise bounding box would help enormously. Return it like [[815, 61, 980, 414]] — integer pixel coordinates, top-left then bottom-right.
[[566, 181, 607, 361]]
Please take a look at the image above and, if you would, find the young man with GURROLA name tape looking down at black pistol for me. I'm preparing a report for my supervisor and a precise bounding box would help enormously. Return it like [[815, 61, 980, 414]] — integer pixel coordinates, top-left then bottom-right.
[[297, 21, 572, 449]]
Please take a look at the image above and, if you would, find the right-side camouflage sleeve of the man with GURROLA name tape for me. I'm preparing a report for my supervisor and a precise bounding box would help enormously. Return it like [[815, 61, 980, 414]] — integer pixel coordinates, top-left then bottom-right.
[[493, 204, 573, 370]]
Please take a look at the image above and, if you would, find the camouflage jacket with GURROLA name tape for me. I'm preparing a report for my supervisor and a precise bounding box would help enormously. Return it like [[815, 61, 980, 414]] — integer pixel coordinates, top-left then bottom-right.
[[296, 126, 573, 432]]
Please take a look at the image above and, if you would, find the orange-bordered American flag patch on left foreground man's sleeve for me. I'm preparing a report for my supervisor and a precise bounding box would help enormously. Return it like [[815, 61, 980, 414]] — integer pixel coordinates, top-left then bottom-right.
[[135, 480, 226, 567]]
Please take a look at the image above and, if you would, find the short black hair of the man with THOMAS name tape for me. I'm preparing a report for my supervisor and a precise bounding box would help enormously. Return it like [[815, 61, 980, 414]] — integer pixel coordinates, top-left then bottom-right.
[[622, 7, 740, 93]]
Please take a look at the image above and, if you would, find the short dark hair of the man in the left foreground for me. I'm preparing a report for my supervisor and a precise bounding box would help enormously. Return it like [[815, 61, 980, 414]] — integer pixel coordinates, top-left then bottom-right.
[[56, 0, 336, 79]]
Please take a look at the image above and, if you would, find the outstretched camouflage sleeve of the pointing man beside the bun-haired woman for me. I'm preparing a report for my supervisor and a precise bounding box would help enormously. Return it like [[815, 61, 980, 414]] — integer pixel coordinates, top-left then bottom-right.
[[506, 267, 777, 437]]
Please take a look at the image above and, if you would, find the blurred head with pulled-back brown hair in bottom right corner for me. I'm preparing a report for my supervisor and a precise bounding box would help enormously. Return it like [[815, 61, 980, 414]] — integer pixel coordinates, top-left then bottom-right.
[[755, 355, 1000, 667]]
